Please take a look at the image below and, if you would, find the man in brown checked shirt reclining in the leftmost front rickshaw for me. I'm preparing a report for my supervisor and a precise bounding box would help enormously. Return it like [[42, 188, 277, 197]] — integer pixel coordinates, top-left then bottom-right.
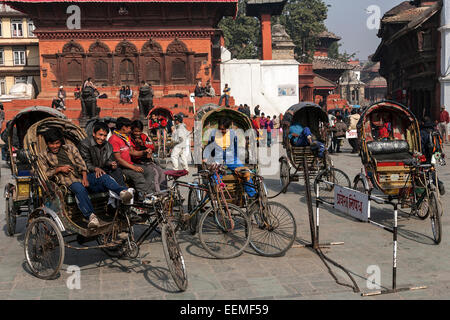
[[40, 128, 133, 228]]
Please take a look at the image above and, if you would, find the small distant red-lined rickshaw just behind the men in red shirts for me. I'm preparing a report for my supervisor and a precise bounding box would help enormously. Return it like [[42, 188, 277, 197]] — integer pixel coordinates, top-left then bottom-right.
[[148, 107, 174, 160]]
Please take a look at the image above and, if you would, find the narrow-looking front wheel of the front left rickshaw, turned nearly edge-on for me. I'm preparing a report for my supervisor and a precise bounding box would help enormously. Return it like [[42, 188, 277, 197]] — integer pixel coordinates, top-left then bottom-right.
[[161, 223, 188, 291]]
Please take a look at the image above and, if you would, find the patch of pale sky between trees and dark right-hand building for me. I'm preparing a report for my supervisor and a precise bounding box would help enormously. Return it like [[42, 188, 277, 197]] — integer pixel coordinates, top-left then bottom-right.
[[324, 0, 404, 60]]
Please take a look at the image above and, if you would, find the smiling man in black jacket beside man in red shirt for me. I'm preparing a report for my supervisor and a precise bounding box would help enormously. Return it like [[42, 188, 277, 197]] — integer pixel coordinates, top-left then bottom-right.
[[79, 122, 126, 187]]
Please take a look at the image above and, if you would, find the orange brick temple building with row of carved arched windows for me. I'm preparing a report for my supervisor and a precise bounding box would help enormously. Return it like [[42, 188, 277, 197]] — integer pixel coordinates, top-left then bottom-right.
[[6, 0, 237, 98]]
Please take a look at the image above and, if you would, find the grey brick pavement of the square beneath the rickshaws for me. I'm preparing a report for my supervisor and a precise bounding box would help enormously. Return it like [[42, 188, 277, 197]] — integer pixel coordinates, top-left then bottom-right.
[[0, 141, 450, 300]]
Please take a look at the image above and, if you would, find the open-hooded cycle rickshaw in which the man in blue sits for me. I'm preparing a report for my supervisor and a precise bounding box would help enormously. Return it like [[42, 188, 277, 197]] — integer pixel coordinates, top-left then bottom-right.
[[188, 104, 297, 256]]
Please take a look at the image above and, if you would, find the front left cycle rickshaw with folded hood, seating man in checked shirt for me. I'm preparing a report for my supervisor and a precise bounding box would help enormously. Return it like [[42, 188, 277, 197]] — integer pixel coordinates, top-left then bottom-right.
[[24, 119, 187, 291]]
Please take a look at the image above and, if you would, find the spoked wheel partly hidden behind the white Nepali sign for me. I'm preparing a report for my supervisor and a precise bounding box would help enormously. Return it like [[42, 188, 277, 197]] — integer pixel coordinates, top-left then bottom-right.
[[314, 168, 351, 204]]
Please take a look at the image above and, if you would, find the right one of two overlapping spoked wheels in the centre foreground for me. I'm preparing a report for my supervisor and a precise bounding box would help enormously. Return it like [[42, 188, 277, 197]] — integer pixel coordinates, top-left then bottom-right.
[[249, 202, 297, 257]]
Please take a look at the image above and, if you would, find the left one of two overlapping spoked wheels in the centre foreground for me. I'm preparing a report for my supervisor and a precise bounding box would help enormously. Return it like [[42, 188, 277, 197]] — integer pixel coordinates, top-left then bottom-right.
[[198, 204, 252, 259]]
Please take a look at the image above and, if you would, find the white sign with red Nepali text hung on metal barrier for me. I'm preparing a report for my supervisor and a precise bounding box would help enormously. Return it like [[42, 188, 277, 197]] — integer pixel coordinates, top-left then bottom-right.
[[334, 185, 369, 222]]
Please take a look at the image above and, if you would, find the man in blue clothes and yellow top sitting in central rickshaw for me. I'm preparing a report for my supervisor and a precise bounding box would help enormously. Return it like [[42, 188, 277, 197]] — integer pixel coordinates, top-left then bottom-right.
[[203, 118, 256, 198]]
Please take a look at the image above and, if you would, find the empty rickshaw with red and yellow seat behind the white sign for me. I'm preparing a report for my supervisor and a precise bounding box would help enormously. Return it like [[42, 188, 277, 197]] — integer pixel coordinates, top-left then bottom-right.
[[353, 101, 443, 244]]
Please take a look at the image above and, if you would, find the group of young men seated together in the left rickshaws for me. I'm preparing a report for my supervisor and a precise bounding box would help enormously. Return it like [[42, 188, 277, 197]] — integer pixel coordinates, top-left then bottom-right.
[[40, 117, 167, 228]]
